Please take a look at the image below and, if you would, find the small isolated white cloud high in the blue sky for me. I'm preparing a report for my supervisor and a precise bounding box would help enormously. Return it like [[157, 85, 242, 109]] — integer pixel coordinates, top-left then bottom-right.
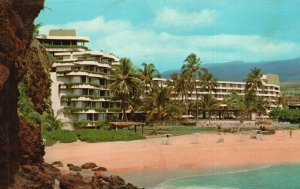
[[155, 8, 216, 28]]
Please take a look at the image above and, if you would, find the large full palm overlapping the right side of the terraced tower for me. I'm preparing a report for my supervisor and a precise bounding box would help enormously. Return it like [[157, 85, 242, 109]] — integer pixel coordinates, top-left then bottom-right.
[[110, 58, 142, 120]]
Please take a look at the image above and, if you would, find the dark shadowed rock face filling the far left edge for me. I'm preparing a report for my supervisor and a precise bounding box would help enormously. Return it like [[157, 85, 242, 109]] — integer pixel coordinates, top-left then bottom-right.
[[0, 0, 44, 188]]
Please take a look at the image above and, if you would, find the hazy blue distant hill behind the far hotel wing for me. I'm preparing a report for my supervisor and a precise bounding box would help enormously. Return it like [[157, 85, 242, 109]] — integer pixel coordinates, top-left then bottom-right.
[[161, 58, 300, 85]]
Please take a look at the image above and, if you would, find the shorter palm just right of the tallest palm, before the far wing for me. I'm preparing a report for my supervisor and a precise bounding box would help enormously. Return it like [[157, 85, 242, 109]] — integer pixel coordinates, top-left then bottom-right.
[[198, 68, 218, 120]]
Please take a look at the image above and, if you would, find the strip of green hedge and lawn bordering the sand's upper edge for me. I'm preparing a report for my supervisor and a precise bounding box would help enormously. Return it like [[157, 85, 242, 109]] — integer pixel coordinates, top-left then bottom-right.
[[43, 126, 258, 146]]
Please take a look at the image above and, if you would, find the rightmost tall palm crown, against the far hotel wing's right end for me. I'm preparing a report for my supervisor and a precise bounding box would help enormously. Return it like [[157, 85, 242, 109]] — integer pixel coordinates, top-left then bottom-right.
[[245, 68, 264, 92]]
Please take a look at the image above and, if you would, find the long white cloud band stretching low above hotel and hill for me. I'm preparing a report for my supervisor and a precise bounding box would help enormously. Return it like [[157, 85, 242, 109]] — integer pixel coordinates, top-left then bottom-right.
[[41, 17, 300, 71]]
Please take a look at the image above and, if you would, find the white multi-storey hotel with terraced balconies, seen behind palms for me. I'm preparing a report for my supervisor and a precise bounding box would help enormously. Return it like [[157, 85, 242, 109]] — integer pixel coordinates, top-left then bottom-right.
[[37, 30, 280, 127]]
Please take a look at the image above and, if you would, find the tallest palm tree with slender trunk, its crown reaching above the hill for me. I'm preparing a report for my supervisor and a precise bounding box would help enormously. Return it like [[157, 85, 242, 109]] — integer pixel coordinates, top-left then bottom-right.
[[181, 53, 201, 123]]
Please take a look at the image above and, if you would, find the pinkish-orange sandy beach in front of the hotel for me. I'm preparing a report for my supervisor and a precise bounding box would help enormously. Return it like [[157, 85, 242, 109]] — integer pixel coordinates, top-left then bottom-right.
[[44, 131, 300, 187]]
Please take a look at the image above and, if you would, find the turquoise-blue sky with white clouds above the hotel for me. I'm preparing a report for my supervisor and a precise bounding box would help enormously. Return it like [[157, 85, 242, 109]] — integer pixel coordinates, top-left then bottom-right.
[[35, 0, 300, 72]]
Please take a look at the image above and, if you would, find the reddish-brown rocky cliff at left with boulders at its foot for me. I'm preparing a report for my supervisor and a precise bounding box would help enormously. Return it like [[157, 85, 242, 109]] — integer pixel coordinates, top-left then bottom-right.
[[0, 0, 137, 189]]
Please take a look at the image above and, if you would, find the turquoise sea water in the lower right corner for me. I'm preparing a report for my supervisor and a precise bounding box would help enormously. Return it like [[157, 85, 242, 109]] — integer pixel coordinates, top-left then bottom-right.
[[159, 164, 300, 189]]
